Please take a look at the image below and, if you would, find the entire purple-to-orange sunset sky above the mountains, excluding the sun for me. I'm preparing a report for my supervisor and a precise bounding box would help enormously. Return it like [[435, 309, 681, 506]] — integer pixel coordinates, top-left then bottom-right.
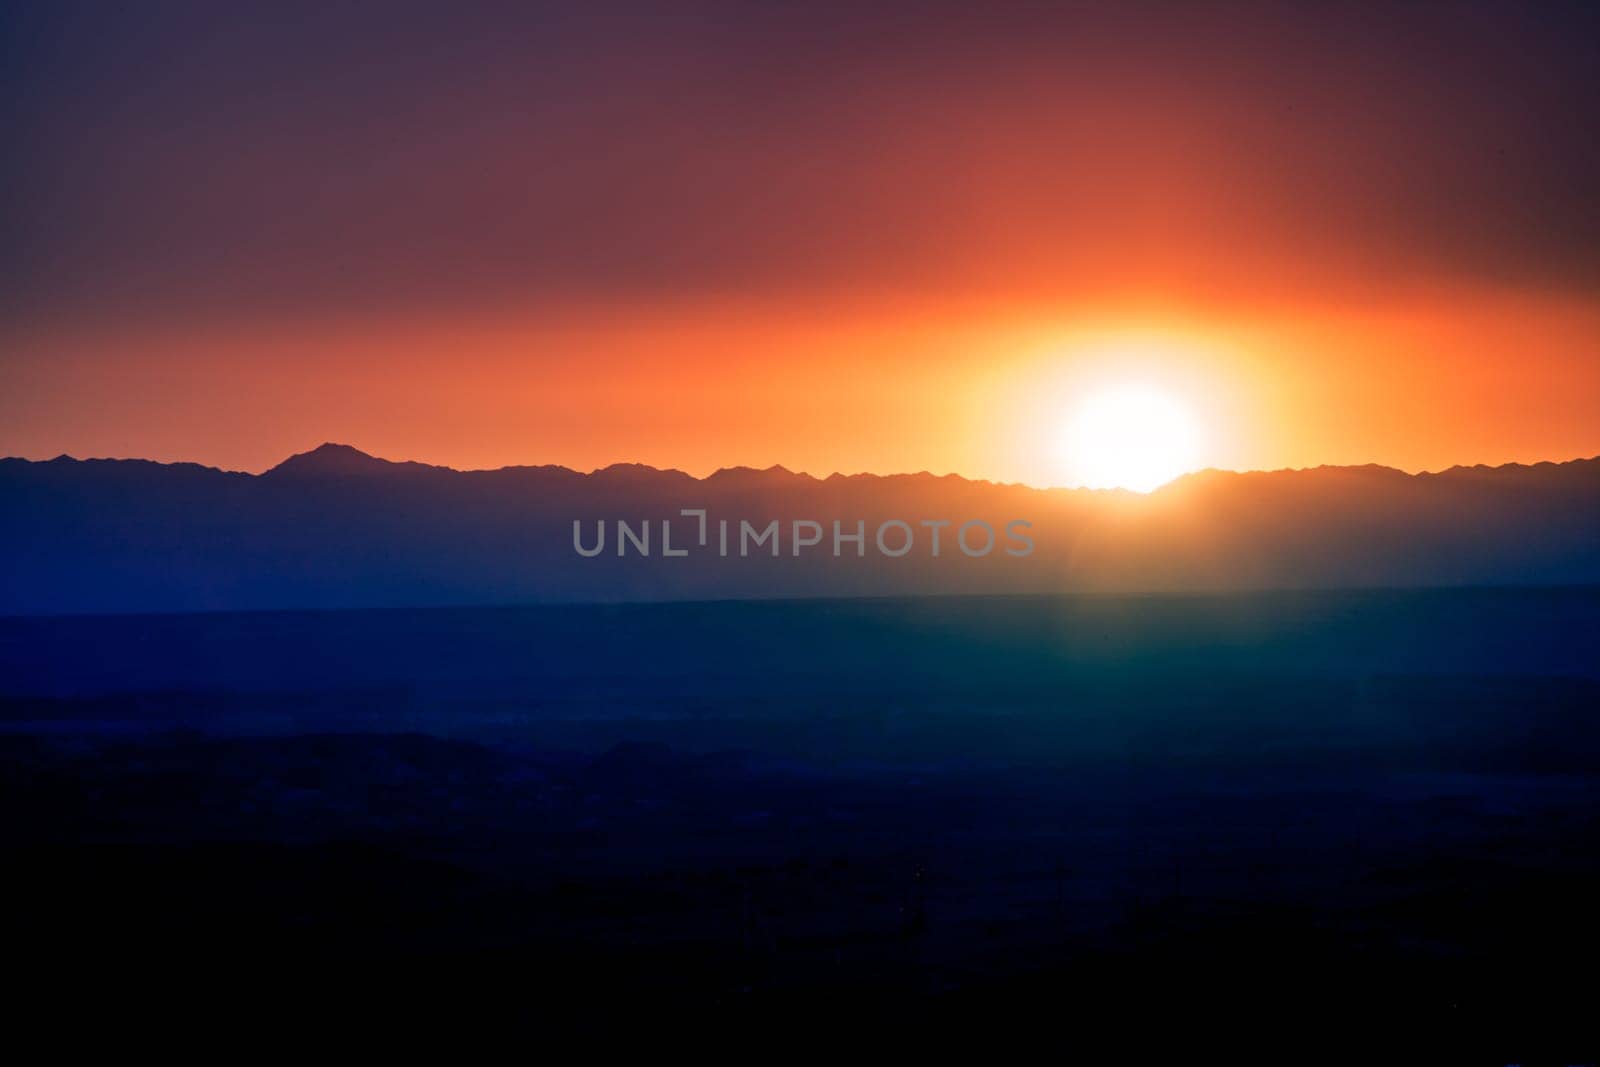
[[0, 2, 1600, 485]]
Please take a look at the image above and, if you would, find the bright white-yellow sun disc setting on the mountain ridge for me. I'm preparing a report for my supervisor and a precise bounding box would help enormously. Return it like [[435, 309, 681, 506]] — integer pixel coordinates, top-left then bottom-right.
[[1062, 384, 1202, 493]]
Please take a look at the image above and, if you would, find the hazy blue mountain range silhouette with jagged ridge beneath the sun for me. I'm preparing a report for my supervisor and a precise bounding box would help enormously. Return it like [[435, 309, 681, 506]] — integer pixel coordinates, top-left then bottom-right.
[[0, 443, 1600, 614]]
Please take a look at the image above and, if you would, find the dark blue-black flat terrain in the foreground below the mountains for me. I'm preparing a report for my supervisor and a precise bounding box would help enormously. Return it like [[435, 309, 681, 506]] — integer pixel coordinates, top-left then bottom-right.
[[0, 589, 1600, 1062]]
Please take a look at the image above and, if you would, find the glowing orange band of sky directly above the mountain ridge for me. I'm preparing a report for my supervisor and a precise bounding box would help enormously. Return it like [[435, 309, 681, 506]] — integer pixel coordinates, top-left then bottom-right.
[[0, 283, 1600, 488]]
